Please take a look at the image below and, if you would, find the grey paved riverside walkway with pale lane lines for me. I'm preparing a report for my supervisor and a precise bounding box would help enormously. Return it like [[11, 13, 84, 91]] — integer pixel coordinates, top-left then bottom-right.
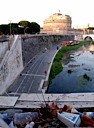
[[7, 46, 57, 96]]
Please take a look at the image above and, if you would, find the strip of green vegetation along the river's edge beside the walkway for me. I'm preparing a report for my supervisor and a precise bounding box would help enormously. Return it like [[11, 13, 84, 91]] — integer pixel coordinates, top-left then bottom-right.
[[49, 41, 91, 85]]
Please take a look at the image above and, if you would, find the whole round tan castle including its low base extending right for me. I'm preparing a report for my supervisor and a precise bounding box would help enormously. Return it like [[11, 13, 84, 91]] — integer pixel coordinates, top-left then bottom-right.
[[41, 12, 82, 34]]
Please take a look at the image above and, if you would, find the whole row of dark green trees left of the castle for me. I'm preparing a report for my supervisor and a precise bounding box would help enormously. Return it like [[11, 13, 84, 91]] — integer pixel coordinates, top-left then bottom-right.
[[0, 20, 40, 35]]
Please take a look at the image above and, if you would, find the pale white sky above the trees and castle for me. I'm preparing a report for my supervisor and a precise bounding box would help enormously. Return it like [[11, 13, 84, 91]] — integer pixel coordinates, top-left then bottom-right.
[[0, 0, 94, 27]]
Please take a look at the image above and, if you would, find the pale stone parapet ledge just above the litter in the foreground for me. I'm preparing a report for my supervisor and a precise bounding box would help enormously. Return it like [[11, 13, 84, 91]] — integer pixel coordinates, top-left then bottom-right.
[[0, 93, 94, 108]]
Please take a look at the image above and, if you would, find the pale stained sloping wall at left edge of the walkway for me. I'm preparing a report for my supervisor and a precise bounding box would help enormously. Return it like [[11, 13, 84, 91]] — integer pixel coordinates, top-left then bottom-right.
[[0, 36, 23, 94]]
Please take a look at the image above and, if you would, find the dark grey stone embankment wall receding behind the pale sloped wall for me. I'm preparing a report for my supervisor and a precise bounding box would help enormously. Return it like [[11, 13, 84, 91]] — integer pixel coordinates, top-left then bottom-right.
[[22, 34, 74, 66]]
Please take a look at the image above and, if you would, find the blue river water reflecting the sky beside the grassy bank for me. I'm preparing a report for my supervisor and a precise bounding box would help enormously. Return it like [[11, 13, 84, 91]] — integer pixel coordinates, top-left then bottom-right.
[[48, 44, 94, 93]]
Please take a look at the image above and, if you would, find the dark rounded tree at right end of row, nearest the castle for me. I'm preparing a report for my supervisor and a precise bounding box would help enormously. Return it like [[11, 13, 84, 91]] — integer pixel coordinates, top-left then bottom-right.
[[29, 22, 40, 34]]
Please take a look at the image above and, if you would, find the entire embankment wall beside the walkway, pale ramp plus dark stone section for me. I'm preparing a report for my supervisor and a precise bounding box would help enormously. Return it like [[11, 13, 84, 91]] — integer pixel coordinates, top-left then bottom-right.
[[0, 34, 74, 94]]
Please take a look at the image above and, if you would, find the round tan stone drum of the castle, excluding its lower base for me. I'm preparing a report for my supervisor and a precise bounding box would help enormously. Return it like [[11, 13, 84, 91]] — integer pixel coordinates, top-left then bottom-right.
[[43, 13, 72, 31]]
